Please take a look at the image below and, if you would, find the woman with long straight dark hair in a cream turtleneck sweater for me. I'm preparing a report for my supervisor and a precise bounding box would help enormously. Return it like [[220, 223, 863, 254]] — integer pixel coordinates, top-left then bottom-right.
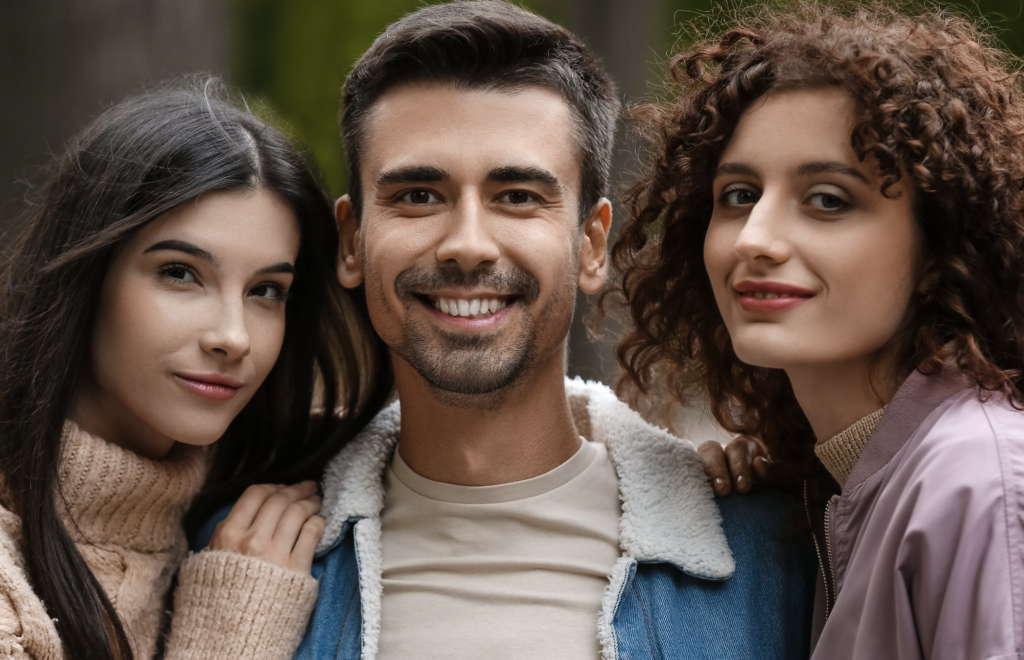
[[0, 79, 391, 660]]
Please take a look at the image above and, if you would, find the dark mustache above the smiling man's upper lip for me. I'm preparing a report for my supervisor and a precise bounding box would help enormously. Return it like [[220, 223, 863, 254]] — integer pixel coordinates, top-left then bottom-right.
[[394, 266, 541, 304]]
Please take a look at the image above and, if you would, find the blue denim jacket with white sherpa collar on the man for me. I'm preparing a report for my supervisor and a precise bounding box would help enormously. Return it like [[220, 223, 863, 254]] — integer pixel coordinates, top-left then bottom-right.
[[272, 380, 816, 660]]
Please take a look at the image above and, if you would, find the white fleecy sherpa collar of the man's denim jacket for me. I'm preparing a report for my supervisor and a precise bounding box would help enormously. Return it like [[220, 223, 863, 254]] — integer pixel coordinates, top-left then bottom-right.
[[316, 379, 735, 579]]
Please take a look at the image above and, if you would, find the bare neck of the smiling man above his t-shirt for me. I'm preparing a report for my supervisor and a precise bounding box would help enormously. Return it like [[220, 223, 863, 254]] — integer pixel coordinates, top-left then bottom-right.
[[394, 357, 580, 486]]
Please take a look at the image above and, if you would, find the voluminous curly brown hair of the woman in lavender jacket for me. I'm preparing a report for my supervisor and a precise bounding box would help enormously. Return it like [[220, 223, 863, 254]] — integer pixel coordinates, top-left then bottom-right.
[[612, 3, 1024, 483]]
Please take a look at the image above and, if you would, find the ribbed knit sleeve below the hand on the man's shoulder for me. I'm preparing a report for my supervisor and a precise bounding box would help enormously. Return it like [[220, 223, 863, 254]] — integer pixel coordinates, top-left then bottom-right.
[[166, 549, 317, 660]]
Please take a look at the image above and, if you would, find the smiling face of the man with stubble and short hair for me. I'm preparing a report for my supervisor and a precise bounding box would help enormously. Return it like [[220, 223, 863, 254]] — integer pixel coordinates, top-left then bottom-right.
[[339, 85, 610, 398]]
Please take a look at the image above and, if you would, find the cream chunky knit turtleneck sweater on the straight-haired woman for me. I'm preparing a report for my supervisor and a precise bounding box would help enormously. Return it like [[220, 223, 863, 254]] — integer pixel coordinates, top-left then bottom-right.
[[0, 423, 316, 660]]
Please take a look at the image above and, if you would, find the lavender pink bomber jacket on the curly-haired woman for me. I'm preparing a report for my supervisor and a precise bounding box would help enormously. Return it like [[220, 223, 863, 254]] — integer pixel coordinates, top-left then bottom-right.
[[811, 368, 1024, 660]]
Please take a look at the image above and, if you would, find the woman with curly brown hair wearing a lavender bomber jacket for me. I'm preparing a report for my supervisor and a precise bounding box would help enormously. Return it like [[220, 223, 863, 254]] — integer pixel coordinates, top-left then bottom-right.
[[614, 5, 1024, 659]]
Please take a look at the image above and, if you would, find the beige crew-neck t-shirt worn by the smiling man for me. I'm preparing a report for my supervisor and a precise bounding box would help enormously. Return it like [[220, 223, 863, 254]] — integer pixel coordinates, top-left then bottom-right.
[[377, 440, 622, 660]]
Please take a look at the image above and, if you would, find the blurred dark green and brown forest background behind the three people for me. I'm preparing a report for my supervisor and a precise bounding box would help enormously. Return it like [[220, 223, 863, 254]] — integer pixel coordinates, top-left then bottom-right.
[[0, 0, 1024, 390]]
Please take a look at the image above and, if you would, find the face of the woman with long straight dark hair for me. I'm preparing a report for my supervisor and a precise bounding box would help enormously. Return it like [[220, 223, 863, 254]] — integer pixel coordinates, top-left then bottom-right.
[[75, 190, 299, 457]]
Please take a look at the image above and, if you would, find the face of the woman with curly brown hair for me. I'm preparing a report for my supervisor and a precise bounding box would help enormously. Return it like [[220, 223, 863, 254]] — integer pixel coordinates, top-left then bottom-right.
[[705, 89, 920, 375]]
